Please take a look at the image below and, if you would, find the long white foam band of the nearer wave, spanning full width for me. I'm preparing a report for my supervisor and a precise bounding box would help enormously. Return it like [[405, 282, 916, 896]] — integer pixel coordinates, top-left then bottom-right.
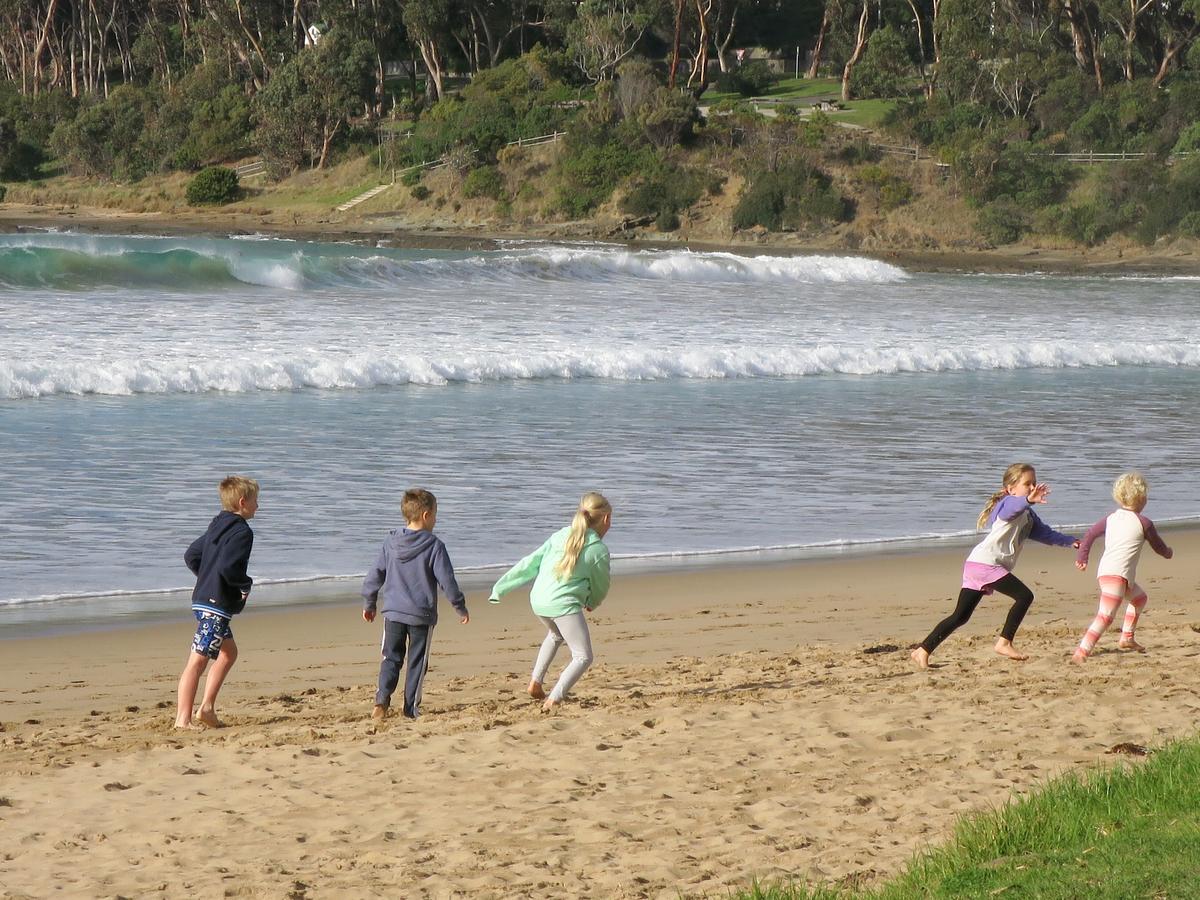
[[0, 342, 1200, 400]]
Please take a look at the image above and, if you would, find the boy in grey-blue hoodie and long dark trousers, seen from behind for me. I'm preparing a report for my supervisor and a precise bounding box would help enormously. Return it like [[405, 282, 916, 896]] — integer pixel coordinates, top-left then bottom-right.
[[362, 487, 470, 719]]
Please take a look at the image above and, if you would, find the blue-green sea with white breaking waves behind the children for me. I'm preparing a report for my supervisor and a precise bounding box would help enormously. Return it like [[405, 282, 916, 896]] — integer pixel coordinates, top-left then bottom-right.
[[0, 233, 1200, 634]]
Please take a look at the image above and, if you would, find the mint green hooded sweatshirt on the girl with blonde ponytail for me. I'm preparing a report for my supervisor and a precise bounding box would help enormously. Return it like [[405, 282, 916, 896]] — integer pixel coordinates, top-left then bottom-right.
[[488, 526, 608, 618]]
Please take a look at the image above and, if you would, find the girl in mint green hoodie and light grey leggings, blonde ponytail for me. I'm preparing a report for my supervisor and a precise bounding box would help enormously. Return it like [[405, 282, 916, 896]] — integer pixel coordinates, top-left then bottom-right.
[[488, 491, 612, 713]]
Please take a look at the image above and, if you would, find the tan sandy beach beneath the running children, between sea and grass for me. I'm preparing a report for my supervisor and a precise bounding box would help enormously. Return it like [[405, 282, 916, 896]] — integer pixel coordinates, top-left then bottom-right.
[[0, 530, 1200, 898]]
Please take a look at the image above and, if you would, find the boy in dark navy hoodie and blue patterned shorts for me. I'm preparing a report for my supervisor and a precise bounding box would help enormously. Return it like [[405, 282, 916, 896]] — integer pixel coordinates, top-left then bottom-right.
[[175, 475, 258, 728]]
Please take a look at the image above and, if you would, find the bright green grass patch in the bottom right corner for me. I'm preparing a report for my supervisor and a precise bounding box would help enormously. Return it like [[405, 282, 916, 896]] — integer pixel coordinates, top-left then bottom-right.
[[734, 739, 1200, 900]]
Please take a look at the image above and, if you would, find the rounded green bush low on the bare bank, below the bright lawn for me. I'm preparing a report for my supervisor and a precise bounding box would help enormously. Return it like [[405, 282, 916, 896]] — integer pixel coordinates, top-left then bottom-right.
[[733, 160, 852, 232]]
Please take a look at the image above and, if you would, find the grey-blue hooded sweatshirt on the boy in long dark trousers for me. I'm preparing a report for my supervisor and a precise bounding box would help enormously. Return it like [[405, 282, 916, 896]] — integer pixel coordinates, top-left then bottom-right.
[[362, 528, 467, 625]]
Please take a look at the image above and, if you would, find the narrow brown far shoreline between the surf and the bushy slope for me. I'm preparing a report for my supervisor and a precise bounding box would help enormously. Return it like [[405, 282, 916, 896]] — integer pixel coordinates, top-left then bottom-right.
[[9, 203, 1200, 277]]
